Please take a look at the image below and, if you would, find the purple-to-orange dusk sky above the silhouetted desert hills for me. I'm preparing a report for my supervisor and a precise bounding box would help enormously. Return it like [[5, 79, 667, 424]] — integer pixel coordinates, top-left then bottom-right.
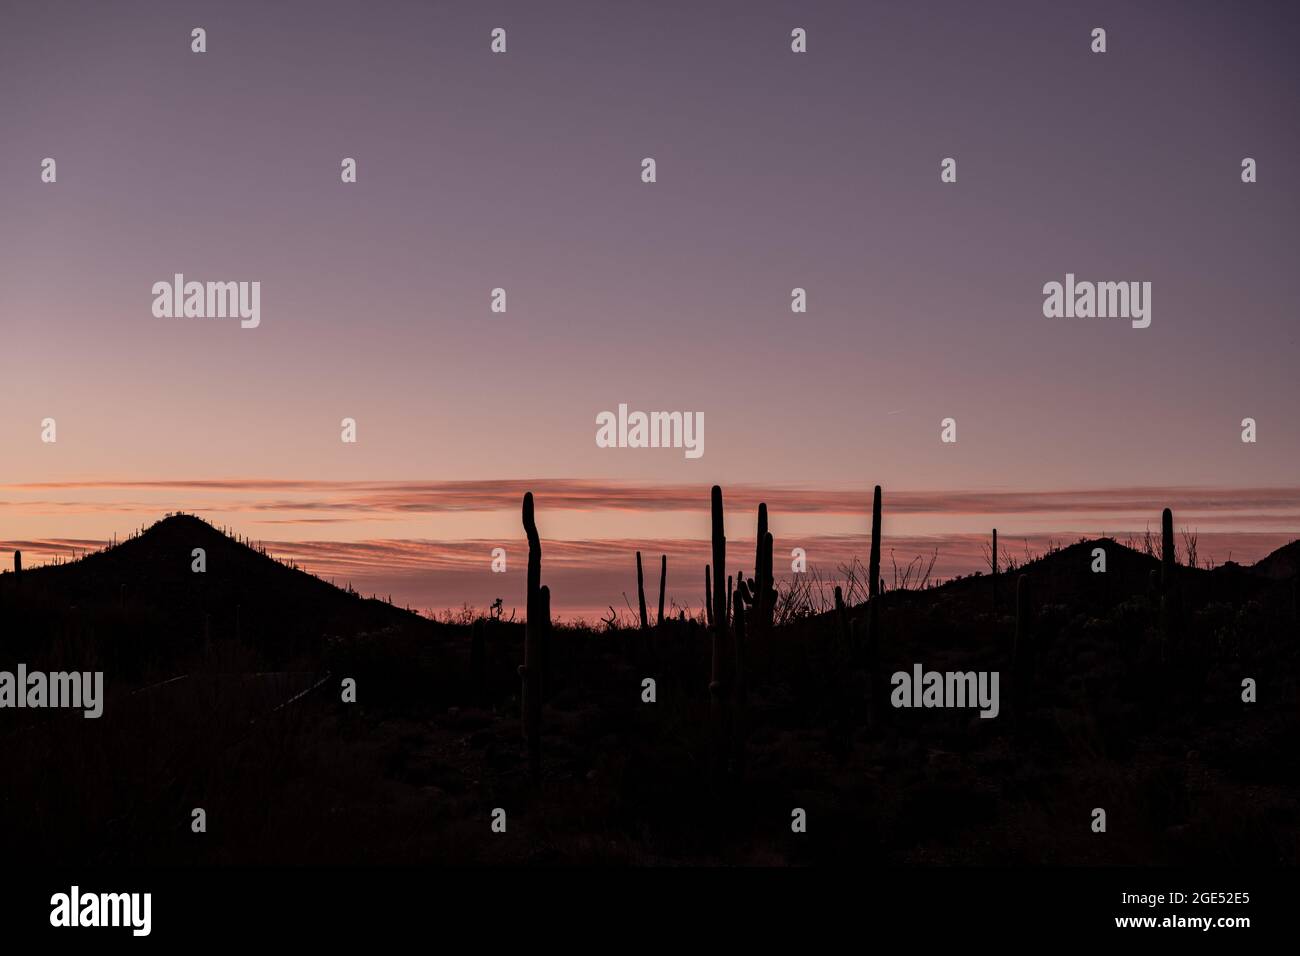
[[0, 0, 1300, 614]]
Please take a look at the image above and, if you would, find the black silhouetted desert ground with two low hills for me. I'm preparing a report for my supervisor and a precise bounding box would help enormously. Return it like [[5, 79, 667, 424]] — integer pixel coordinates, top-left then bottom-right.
[[0, 516, 1300, 866]]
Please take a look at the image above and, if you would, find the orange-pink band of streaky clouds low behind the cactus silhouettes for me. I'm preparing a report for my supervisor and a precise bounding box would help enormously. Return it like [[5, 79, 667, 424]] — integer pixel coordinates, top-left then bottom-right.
[[0, 479, 1300, 623]]
